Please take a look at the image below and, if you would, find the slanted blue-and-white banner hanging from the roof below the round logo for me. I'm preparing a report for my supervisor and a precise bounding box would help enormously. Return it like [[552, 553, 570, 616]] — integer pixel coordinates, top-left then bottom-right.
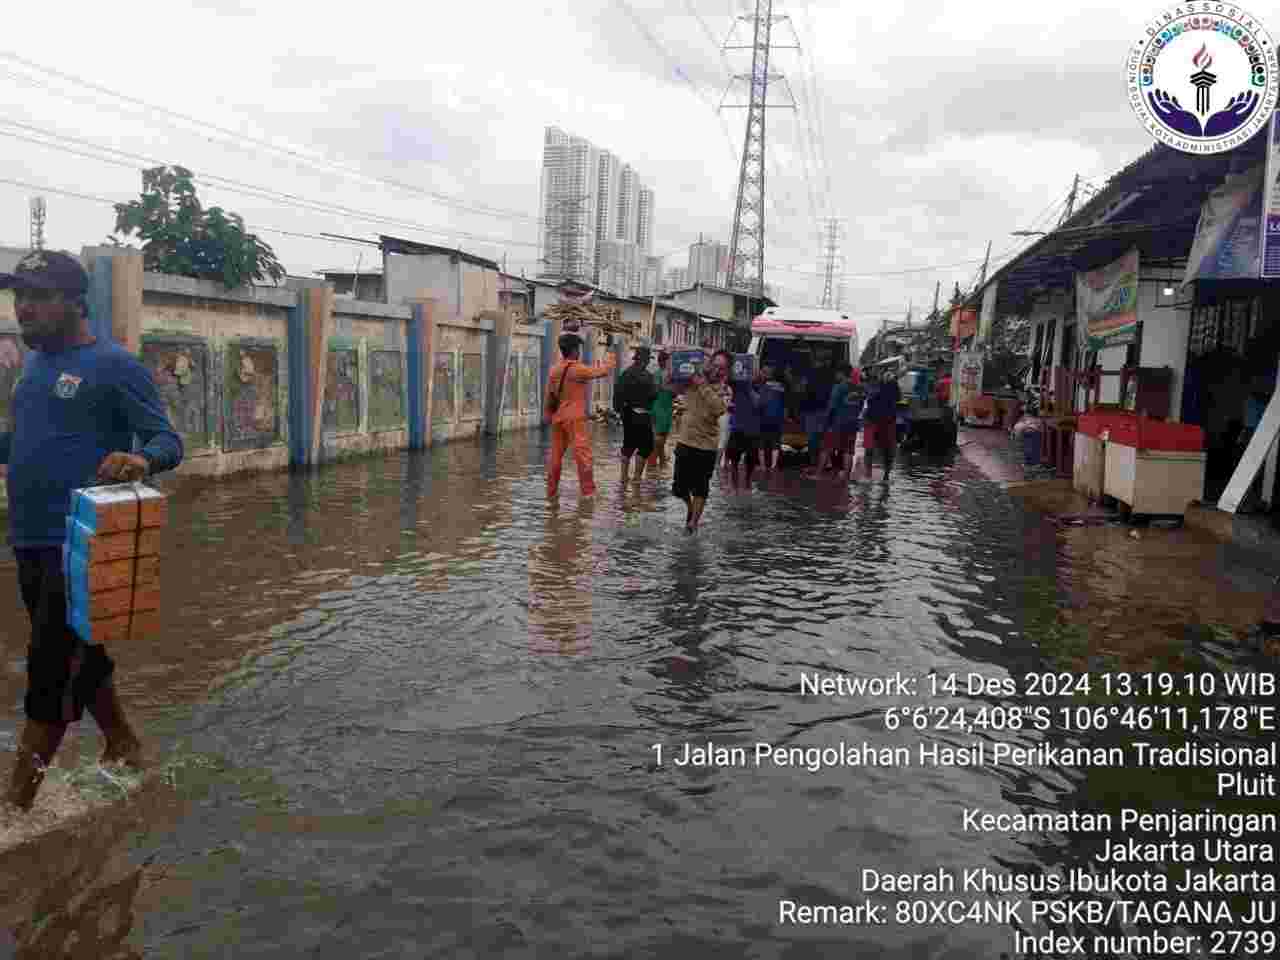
[[1183, 164, 1265, 287]]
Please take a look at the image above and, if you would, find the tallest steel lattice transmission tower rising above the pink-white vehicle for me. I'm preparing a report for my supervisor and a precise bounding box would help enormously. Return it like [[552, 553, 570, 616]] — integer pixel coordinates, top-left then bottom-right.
[[721, 0, 799, 297]]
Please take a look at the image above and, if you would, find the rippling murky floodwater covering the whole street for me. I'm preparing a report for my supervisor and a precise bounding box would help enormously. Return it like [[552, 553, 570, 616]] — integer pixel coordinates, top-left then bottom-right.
[[0, 430, 1274, 960]]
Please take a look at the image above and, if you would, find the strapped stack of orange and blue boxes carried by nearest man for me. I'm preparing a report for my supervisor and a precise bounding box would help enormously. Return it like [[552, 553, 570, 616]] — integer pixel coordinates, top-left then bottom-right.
[[63, 484, 169, 644]]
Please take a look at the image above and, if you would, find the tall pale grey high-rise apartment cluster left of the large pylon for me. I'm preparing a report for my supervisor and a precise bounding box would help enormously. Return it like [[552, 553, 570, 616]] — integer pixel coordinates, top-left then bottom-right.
[[539, 127, 654, 296]]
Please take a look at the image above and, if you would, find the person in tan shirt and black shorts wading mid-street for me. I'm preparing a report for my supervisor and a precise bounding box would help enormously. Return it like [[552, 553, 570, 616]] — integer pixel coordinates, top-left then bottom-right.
[[671, 355, 733, 534]]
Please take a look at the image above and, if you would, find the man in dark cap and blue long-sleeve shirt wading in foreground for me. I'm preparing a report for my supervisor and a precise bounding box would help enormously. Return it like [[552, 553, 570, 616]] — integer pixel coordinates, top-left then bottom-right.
[[0, 251, 182, 810]]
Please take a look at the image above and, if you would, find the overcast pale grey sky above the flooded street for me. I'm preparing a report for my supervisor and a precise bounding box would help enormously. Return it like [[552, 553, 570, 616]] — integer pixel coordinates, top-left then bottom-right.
[[0, 0, 1160, 343]]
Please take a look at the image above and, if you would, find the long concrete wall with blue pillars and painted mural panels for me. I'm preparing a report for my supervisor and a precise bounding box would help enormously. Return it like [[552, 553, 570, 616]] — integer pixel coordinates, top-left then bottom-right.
[[0, 247, 545, 512]]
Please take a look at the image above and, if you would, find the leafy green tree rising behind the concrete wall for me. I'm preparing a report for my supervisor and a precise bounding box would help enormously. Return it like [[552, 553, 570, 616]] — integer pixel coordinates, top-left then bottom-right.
[[109, 166, 284, 288]]
